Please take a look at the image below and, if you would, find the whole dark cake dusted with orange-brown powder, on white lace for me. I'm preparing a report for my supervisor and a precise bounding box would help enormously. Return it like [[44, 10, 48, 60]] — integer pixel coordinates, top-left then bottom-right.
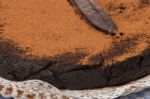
[[0, 0, 150, 89]]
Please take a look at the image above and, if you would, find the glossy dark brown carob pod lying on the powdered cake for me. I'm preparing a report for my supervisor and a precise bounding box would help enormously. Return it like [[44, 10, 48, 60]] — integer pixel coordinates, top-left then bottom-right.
[[69, 0, 117, 35]]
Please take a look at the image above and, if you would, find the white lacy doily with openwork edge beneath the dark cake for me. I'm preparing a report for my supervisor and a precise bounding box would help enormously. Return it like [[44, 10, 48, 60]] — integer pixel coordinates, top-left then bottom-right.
[[0, 75, 150, 99]]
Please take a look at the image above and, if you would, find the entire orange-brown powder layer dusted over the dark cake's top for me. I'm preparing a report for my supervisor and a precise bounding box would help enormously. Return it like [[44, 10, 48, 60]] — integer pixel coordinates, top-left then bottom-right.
[[0, 0, 150, 67]]
